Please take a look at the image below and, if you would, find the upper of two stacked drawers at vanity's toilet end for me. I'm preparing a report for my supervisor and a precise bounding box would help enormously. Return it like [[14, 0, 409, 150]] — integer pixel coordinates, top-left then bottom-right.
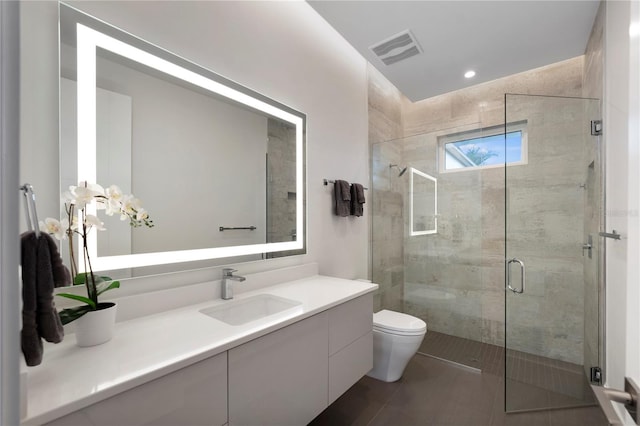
[[329, 294, 373, 355]]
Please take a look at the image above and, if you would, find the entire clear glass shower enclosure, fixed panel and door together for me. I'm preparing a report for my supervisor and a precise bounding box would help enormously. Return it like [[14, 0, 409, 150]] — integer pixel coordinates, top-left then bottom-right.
[[371, 94, 603, 412]]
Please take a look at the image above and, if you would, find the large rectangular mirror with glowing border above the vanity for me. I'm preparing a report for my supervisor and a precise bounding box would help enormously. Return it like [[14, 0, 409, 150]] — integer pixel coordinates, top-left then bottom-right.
[[60, 4, 305, 275]]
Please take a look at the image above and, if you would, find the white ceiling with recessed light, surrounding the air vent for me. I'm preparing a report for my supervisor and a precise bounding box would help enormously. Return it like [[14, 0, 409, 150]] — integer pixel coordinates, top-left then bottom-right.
[[308, 0, 599, 101]]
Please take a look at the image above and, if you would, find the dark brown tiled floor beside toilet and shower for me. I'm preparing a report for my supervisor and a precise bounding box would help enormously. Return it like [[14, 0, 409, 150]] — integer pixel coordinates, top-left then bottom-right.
[[310, 332, 608, 426]]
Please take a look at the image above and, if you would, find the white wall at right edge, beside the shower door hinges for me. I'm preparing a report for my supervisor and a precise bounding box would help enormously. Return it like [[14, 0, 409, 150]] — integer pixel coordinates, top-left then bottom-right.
[[604, 1, 640, 420]]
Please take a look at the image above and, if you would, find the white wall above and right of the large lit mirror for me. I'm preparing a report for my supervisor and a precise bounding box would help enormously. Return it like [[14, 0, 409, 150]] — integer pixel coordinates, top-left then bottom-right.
[[21, 1, 369, 290]]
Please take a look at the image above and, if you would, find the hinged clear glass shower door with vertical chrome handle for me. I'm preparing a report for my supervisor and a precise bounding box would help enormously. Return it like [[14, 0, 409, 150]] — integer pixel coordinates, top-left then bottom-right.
[[504, 94, 602, 412]]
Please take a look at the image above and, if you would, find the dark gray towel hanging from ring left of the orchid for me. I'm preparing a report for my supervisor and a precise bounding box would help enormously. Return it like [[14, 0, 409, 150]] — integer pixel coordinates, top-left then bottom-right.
[[21, 231, 71, 366]]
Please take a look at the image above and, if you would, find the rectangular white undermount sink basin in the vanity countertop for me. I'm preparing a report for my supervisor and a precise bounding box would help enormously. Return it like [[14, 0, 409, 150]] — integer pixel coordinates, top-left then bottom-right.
[[200, 294, 302, 325]]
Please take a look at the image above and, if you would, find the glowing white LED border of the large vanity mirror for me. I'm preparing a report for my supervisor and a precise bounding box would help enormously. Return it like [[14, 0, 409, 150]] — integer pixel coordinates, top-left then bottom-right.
[[60, 2, 306, 271]]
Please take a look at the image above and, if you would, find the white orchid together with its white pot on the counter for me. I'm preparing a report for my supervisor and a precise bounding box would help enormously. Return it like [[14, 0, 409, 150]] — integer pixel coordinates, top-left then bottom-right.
[[40, 182, 153, 346]]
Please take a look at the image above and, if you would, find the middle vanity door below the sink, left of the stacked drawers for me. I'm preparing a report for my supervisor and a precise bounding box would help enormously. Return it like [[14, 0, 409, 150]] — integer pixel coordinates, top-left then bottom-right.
[[229, 313, 328, 426]]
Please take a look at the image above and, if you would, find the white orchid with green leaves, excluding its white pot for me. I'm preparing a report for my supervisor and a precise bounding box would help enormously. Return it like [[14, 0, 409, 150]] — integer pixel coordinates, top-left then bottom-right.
[[39, 182, 153, 324]]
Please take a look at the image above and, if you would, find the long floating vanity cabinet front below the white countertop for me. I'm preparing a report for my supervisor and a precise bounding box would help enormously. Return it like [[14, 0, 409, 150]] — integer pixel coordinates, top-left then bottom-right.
[[37, 293, 373, 426]]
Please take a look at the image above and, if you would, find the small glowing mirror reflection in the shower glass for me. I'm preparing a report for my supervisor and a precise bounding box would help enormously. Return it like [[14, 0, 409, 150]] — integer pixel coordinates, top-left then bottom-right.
[[409, 167, 438, 236]]
